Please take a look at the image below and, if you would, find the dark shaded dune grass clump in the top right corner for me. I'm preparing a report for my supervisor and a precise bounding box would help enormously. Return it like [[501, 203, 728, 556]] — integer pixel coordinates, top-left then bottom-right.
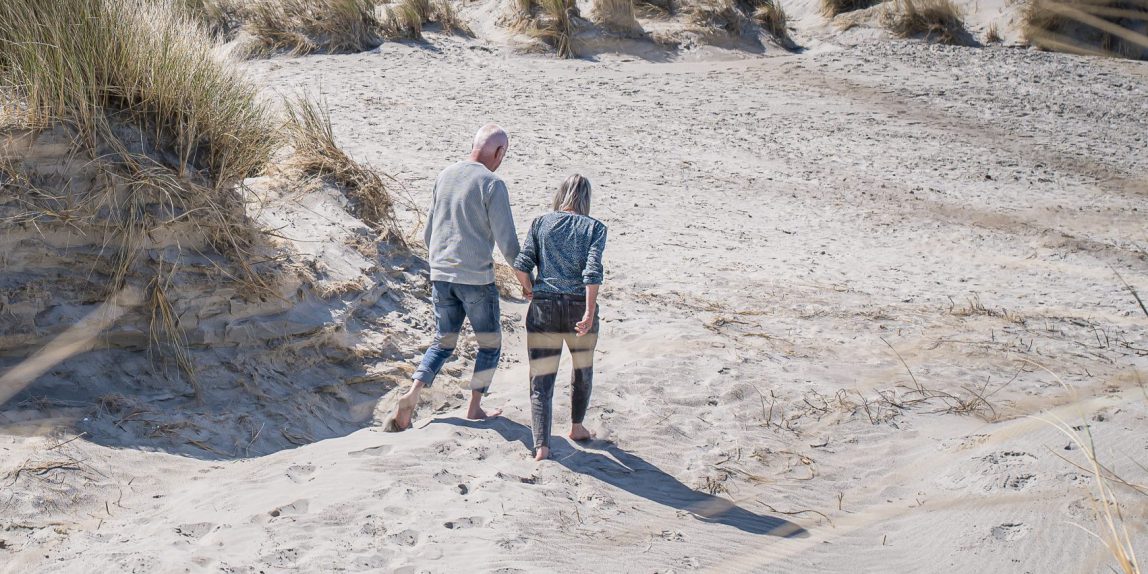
[[1021, 0, 1148, 60]]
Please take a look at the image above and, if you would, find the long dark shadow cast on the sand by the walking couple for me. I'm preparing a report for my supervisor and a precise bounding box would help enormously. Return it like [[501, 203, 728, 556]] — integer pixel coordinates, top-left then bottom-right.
[[431, 417, 809, 538]]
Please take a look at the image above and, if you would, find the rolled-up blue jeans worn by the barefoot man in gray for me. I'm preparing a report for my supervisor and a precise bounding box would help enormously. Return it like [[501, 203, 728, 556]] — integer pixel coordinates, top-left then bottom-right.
[[413, 281, 502, 394]]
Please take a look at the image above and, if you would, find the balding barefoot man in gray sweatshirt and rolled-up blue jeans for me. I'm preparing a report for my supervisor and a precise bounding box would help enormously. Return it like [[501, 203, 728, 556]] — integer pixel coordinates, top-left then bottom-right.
[[393, 124, 519, 431]]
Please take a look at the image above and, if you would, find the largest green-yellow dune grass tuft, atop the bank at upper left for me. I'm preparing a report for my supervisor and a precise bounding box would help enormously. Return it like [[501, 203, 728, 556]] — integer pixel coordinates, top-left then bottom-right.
[[0, 0, 274, 195]]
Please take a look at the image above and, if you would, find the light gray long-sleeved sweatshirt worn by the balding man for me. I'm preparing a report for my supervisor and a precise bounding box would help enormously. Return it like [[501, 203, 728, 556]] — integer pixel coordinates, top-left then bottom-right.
[[422, 161, 518, 285]]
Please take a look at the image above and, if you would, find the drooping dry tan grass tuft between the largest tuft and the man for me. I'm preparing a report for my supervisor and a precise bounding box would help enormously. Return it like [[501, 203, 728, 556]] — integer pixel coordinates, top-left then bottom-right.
[[286, 96, 403, 245]]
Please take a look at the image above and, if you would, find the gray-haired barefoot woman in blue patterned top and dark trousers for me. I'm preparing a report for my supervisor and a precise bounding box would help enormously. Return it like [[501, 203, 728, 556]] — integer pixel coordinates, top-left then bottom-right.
[[514, 173, 606, 460]]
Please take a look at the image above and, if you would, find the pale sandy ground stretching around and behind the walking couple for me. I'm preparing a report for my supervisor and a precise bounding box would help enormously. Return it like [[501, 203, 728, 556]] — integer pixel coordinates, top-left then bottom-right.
[[0, 12, 1148, 573]]
